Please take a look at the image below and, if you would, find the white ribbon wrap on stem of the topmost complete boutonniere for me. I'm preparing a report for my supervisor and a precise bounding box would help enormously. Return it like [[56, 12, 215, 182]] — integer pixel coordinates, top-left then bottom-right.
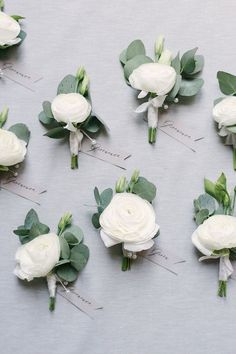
[[135, 95, 166, 128]]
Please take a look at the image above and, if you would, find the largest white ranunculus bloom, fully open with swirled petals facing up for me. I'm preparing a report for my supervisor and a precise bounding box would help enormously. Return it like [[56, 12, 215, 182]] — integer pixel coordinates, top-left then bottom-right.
[[99, 193, 159, 252]]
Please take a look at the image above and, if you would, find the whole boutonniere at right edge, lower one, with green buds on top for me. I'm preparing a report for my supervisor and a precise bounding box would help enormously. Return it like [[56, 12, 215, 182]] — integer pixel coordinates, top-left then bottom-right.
[[192, 173, 236, 297]]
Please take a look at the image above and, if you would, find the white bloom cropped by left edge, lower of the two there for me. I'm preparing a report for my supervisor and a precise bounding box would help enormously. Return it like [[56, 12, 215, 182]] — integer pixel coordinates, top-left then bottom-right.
[[0, 129, 26, 166]]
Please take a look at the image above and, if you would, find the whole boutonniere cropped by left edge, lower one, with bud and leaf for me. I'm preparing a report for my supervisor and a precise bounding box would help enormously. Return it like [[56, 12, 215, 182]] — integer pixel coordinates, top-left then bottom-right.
[[0, 107, 30, 176]]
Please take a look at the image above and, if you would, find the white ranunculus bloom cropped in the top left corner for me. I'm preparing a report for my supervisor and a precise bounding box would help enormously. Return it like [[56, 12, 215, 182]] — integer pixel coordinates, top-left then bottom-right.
[[0, 11, 21, 45]]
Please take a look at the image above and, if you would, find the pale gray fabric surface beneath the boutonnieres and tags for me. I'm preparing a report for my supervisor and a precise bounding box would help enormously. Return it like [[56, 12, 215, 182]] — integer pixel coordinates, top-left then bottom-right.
[[0, 0, 236, 354]]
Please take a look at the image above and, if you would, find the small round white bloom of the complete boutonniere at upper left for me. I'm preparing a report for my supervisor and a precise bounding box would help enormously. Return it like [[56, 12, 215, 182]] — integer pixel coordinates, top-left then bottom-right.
[[51, 93, 91, 125]]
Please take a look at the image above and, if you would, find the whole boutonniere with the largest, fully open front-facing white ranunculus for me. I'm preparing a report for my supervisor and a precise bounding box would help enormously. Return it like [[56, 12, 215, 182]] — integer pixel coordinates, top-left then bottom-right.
[[92, 171, 159, 271]]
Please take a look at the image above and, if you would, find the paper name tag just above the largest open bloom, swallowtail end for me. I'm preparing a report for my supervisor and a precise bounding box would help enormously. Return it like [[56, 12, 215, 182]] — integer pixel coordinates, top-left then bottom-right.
[[81, 140, 131, 170]]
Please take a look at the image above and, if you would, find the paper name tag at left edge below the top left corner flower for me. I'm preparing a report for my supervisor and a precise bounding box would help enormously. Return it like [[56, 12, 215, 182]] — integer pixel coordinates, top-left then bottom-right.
[[0, 62, 43, 92]]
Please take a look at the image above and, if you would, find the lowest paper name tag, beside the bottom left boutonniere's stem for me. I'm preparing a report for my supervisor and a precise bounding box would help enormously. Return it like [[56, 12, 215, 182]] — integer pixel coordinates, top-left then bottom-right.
[[57, 286, 103, 318]]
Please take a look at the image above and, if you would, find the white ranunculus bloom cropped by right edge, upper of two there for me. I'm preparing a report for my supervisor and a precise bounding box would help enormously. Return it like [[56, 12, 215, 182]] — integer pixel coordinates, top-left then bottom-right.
[[213, 96, 236, 128]]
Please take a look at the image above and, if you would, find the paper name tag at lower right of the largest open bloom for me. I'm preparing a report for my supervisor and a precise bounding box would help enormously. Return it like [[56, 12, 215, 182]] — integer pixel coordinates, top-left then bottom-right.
[[141, 244, 186, 275]]
